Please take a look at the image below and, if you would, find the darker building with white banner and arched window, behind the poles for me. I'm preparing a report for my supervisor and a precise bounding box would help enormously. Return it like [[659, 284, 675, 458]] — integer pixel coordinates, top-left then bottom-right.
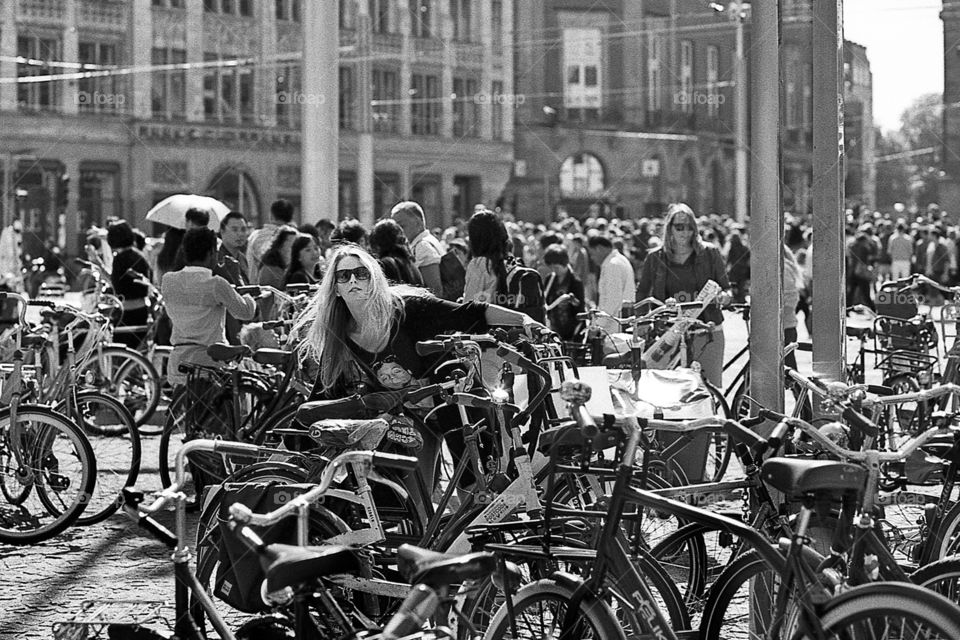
[[504, 0, 873, 220]]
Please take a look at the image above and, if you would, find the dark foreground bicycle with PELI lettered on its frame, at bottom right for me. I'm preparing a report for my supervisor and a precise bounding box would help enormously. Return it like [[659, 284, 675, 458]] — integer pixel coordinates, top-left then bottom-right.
[[484, 380, 960, 640]]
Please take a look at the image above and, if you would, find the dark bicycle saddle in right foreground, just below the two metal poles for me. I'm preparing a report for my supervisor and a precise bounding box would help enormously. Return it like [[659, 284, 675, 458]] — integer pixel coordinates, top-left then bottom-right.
[[760, 458, 867, 497]]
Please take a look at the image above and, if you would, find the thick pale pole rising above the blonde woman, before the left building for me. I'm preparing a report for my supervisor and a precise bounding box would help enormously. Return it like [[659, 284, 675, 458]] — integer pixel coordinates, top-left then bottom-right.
[[300, 2, 340, 220]]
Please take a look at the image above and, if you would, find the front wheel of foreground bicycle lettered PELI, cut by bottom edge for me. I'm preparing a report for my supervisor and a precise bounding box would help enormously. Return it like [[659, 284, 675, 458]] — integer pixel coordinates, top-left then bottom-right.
[[483, 579, 626, 640]]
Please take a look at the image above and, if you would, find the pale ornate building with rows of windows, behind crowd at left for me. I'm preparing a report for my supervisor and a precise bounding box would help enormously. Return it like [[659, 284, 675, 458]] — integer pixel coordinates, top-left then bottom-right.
[[0, 0, 514, 255]]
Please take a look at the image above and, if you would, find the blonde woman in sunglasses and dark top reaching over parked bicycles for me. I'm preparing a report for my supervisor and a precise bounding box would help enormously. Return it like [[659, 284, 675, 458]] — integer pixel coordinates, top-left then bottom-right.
[[293, 244, 542, 486]]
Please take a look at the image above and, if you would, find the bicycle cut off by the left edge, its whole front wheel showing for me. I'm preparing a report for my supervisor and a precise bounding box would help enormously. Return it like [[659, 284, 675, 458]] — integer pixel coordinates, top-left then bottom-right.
[[0, 292, 97, 544]]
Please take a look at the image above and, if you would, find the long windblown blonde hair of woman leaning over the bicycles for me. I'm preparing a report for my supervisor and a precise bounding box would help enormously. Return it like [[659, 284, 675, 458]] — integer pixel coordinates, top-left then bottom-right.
[[292, 243, 422, 392]]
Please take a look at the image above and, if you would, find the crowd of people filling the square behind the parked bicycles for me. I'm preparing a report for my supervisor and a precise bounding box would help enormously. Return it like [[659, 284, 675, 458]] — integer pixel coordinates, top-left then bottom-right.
[[84, 200, 960, 402]]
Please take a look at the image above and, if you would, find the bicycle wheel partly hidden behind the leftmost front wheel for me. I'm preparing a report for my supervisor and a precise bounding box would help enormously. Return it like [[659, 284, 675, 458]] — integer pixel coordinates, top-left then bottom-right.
[[55, 391, 142, 526]]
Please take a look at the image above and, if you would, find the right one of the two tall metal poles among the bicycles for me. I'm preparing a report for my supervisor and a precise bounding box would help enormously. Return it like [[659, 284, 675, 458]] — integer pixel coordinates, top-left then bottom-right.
[[812, 0, 846, 390]]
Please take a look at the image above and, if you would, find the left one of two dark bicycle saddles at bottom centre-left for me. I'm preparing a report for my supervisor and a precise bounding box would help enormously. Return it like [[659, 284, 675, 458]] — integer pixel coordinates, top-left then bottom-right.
[[260, 543, 360, 593]]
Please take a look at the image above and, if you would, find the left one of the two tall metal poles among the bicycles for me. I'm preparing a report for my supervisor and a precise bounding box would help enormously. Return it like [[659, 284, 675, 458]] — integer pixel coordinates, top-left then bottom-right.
[[750, 2, 783, 411]]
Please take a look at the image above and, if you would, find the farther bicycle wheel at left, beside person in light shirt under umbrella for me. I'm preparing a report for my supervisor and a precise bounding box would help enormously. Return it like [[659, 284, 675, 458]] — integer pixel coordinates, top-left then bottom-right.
[[77, 347, 161, 428]]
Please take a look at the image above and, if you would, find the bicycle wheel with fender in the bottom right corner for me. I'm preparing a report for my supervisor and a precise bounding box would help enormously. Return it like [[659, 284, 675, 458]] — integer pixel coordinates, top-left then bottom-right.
[[812, 582, 960, 640]]
